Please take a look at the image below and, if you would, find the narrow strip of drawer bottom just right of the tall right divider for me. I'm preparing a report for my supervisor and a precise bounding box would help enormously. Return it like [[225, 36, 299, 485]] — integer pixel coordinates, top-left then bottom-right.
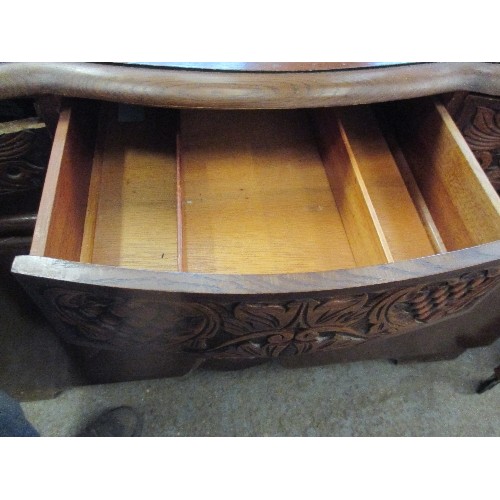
[[336, 106, 435, 261]]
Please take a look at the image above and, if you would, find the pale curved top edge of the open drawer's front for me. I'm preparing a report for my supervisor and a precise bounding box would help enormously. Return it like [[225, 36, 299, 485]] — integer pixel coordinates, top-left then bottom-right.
[[12, 241, 500, 295]]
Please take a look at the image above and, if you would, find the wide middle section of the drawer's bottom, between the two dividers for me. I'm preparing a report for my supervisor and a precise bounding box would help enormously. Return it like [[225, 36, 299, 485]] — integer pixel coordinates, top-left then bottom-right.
[[181, 110, 356, 274]]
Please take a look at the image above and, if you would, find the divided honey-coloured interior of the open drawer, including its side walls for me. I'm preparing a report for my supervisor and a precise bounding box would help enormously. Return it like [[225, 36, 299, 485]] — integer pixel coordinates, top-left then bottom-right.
[[31, 99, 500, 274]]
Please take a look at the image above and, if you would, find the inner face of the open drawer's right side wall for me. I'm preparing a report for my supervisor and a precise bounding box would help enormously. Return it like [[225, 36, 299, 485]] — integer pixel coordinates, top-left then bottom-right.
[[389, 99, 500, 251]]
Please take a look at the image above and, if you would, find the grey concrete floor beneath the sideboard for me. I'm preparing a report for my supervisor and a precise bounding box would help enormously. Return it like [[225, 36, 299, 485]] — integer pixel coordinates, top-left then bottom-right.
[[22, 341, 500, 436]]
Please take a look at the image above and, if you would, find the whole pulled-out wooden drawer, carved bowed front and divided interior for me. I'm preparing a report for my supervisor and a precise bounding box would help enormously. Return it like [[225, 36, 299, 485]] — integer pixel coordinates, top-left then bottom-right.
[[9, 95, 500, 380]]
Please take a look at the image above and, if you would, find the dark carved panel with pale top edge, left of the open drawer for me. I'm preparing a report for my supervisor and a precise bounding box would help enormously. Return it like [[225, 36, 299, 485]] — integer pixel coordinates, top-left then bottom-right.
[[0, 119, 51, 195]]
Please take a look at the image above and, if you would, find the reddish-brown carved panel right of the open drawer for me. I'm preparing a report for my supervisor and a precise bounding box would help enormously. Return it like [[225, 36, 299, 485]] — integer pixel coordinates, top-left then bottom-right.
[[455, 94, 500, 194]]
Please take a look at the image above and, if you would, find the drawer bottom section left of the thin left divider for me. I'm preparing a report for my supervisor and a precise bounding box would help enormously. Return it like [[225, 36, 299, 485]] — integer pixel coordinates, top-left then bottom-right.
[[87, 110, 177, 271]]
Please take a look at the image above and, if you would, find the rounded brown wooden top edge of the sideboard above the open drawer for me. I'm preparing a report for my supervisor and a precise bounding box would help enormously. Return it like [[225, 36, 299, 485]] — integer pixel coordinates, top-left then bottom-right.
[[0, 63, 500, 109]]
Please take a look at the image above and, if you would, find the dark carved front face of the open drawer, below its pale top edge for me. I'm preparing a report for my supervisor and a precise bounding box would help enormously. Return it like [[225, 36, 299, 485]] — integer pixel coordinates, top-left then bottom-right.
[[21, 268, 500, 359]]
